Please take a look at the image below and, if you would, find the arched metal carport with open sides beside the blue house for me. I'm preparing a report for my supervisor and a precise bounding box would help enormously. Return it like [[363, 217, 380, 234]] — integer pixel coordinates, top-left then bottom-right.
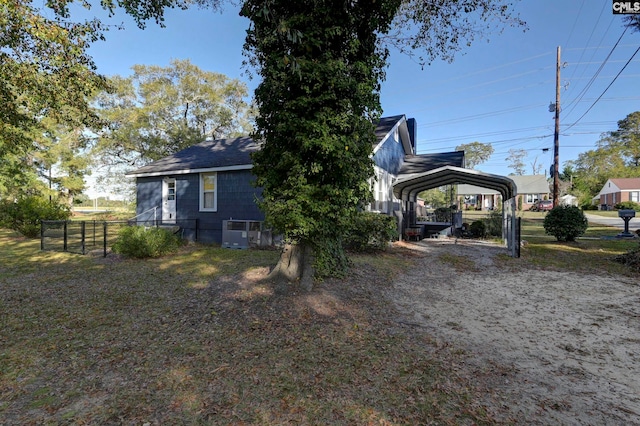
[[393, 166, 520, 257]]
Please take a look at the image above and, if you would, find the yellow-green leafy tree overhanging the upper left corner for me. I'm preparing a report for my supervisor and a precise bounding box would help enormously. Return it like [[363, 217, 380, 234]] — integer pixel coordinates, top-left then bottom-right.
[[0, 0, 225, 196]]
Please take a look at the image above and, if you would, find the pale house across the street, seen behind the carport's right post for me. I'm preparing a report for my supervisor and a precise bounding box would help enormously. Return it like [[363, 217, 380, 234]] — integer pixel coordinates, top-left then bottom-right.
[[458, 175, 550, 210]]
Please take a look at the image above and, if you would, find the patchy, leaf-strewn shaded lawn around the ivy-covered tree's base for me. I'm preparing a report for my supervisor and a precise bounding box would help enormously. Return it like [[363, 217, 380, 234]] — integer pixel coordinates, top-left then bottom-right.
[[0, 230, 508, 425]]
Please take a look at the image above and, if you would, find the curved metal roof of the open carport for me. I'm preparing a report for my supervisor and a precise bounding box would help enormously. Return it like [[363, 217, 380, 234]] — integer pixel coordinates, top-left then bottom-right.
[[393, 166, 518, 201]]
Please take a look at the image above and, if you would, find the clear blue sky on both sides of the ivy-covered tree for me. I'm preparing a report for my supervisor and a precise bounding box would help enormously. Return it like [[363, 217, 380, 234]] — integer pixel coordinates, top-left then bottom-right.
[[82, 0, 640, 175]]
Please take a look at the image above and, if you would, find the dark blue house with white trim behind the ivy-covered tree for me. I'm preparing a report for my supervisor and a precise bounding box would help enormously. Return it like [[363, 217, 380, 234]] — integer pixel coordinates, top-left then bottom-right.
[[127, 115, 464, 245]]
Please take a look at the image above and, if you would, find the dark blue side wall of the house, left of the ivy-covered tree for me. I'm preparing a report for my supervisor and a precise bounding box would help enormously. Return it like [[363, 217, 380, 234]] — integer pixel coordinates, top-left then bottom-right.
[[136, 170, 264, 243]]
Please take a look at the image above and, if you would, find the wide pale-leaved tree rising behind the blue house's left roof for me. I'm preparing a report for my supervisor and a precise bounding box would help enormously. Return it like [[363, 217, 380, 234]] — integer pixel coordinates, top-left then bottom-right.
[[94, 60, 253, 168]]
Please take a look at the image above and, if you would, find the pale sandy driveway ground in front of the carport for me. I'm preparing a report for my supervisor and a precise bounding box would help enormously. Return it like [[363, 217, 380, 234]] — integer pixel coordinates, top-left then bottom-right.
[[390, 239, 640, 425]]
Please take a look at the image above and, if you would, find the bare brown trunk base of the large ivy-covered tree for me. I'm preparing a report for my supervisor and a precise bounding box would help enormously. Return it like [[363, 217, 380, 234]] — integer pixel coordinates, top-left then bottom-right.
[[268, 243, 314, 291]]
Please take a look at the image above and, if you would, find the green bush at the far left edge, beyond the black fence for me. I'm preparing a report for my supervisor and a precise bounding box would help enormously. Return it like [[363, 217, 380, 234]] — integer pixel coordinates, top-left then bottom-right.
[[0, 196, 71, 238]]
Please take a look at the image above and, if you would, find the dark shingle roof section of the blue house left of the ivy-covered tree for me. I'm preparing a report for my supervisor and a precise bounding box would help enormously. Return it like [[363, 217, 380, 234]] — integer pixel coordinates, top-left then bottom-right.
[[130, 137, 258, 175]]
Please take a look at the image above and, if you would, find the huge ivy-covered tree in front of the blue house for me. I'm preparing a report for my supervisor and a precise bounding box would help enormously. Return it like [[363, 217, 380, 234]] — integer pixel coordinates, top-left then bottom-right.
[[241, 0, 524, 283]]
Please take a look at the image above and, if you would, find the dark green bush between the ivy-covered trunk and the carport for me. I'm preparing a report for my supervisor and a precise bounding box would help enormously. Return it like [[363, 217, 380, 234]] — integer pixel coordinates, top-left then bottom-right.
[[344, 212, 398, 251]]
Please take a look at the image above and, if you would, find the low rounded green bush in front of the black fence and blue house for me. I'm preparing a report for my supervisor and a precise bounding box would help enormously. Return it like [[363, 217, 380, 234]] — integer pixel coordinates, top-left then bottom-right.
[[113, 226, 181, 259]]
